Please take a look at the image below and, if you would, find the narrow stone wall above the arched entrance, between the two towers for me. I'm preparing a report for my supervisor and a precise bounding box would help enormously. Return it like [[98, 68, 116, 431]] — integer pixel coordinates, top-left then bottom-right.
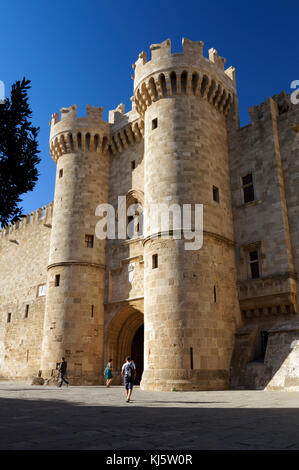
[[106, 130, 144, 303]]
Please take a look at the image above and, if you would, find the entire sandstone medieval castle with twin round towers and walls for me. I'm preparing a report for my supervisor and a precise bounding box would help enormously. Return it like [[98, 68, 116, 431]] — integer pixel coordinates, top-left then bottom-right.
[[0, 39, 299, 390]]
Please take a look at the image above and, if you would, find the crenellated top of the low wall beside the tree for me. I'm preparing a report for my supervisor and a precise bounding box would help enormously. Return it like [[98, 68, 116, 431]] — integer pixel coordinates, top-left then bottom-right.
[[0, 202, 53, 244]]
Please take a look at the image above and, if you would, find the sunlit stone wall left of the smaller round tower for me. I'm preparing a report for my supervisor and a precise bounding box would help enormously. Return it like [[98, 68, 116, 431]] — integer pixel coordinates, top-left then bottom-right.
[[0, 204, 52, 379]]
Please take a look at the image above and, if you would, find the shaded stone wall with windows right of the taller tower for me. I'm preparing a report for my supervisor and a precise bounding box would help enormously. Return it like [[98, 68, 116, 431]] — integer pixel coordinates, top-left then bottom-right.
[[229, 92, 299, 389]]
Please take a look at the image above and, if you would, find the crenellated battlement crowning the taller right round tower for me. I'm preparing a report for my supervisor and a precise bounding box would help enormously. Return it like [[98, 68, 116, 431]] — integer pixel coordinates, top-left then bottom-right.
[[133, 38, 236, 116]]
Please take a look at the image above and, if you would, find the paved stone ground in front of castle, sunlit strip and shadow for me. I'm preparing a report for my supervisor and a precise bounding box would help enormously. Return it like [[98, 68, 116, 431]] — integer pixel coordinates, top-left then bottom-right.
[[0, 382, 299, 450]]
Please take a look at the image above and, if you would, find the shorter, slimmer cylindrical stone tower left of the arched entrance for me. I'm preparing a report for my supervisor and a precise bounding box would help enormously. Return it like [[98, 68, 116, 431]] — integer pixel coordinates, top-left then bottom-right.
[[41, 105, 109, 384]]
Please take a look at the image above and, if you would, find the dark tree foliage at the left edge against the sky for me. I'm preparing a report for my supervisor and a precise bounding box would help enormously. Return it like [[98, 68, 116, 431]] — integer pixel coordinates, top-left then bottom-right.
[[0, 77, 40, 226]]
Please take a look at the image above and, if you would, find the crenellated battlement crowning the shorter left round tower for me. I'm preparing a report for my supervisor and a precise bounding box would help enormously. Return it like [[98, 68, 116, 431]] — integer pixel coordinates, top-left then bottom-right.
[[50, 104, 110, 163]]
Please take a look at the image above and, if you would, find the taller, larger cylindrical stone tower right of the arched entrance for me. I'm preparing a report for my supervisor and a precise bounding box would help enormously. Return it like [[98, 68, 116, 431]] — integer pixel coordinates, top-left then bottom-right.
[[134, 39, 240, 390]]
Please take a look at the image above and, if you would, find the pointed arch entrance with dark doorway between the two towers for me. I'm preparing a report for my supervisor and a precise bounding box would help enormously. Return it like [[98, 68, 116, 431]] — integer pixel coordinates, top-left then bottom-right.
[[104, 305, 144, 385]]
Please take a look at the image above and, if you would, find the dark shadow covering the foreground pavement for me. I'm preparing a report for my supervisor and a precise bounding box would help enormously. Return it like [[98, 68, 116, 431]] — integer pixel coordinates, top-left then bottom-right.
[[0, 398, 299, 450]]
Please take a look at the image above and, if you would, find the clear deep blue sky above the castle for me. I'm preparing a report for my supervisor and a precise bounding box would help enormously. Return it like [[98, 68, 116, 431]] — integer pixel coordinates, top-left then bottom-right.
[[0, 0, 299, 213]]
